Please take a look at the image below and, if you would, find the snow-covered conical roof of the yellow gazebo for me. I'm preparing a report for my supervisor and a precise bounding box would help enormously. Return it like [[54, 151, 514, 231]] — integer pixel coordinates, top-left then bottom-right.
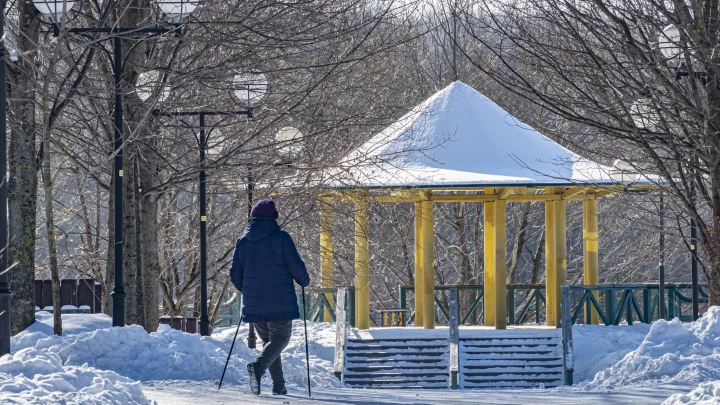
[[341, 81, 614, 187]]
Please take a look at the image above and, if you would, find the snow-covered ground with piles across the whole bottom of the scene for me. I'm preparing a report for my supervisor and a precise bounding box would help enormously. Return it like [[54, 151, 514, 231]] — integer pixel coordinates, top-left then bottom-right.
[[9, 308, 720, 405]]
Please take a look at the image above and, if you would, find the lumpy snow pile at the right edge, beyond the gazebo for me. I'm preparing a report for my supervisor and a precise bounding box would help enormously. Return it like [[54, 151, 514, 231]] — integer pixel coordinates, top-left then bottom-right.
[[582, 307, 720, 389]]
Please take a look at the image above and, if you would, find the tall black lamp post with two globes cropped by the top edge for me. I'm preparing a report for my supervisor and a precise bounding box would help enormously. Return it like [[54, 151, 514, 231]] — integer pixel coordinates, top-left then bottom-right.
[[33, 0, 200, 326]]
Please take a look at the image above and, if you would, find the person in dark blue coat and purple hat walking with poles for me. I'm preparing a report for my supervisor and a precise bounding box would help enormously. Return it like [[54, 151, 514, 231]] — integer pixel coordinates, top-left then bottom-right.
[[230, 200, 310, 395]]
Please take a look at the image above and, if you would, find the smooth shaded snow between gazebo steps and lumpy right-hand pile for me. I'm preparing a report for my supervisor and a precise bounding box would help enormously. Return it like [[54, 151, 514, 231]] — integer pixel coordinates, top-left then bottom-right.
[[573, 323, 650, 383]]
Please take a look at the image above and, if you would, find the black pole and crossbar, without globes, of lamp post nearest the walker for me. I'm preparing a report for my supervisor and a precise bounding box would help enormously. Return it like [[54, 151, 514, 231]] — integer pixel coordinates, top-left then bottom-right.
[[153, 108, 252, 336]]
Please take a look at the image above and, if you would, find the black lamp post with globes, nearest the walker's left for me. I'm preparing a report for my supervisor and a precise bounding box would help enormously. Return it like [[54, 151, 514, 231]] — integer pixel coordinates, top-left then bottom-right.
[[141, 71, 268, 336]]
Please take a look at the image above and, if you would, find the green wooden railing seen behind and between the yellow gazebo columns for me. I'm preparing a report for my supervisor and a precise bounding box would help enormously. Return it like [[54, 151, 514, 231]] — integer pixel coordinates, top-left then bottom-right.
[[205, 284, 708, 327]]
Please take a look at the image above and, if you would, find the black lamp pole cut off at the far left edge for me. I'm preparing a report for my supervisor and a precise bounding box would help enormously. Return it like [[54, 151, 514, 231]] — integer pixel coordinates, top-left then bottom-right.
[[0, 0, 12, 356]]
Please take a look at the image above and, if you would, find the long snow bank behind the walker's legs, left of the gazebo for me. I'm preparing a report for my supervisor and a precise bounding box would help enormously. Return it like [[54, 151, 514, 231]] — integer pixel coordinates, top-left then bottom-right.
[[12, 315, 341, 388]]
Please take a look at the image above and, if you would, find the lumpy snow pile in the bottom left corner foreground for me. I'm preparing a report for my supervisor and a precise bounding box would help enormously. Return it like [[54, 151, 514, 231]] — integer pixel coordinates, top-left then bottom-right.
[[0, 348, 149, 404]]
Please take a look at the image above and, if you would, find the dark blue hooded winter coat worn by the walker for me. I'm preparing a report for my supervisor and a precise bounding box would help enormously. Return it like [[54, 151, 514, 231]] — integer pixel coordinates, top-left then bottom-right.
[[230, 217, 310, 322]]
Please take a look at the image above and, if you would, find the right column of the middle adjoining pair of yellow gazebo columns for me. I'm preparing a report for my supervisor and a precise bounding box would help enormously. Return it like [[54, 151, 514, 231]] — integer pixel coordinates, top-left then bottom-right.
[[493, 200, 507, 329]]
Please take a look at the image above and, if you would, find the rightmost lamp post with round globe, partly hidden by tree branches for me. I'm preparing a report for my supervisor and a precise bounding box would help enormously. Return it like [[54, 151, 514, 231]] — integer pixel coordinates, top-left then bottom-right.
[[658, 25, 696, 321]]
